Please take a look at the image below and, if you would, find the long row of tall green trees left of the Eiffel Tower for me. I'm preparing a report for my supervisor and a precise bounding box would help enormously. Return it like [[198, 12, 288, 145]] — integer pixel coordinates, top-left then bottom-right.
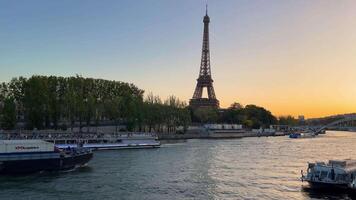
[[0, 76, 190, 131]]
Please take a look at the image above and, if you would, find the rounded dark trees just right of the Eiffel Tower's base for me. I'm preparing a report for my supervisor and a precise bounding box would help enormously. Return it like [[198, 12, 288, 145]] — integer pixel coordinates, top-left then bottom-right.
[[192, 103, 278, 128]]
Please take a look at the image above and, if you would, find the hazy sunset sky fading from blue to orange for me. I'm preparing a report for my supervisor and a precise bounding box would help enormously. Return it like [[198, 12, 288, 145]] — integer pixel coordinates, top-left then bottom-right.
[[0, 0, 356, 117]]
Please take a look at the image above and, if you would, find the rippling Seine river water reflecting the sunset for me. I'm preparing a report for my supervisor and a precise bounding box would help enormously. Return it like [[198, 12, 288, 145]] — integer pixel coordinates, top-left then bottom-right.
[[0, 132, 356, 200]]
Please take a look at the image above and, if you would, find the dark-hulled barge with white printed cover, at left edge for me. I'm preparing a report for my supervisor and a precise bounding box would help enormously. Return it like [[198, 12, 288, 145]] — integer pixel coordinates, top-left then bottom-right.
[[0, 140, 93, 174]]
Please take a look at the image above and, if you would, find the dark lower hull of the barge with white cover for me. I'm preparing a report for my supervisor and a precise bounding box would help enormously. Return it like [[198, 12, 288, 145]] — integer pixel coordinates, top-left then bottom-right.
[[0, 152, 93, 174]]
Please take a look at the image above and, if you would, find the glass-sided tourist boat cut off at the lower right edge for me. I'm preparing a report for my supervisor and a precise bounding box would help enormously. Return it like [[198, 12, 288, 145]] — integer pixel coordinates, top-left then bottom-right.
[[301, 159, 356, 189]]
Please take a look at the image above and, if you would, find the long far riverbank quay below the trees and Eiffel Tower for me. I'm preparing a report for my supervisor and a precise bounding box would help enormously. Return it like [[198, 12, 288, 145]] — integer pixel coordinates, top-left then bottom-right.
[[0, 128, 286, 142]]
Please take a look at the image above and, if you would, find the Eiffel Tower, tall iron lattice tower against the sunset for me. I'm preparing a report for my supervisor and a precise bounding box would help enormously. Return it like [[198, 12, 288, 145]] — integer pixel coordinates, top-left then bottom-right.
[[189, 7, 219, 108]]
